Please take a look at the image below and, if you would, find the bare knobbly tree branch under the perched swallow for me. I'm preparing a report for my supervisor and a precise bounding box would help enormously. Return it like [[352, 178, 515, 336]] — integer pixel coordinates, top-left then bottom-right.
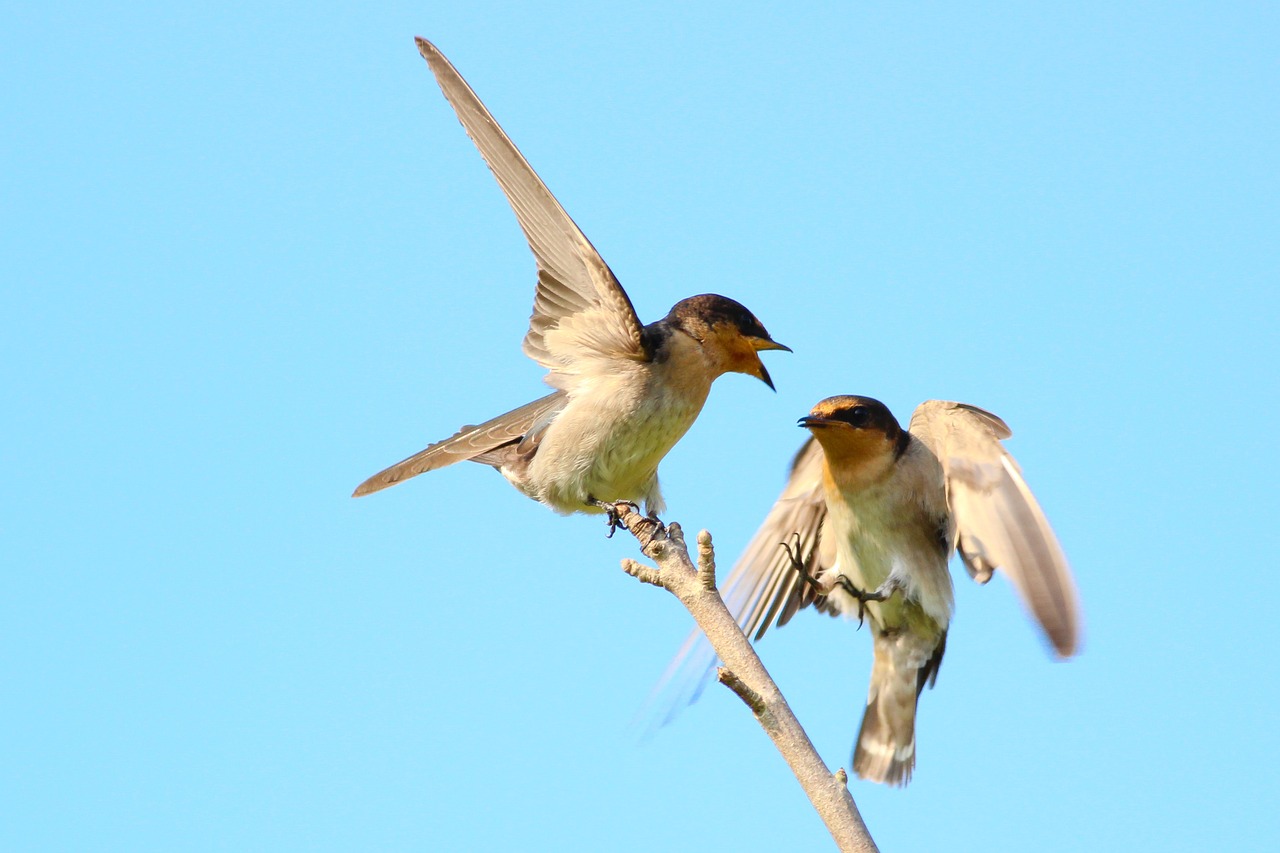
[[618, 503, 877, 853]]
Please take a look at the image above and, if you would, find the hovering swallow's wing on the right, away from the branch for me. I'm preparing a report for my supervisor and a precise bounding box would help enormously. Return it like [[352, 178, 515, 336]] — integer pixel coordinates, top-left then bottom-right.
[[910, 400, 1080, 657]]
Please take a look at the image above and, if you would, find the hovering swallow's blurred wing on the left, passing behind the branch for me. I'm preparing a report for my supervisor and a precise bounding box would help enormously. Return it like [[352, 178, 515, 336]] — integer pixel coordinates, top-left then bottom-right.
[[643, 438, 835, 725]]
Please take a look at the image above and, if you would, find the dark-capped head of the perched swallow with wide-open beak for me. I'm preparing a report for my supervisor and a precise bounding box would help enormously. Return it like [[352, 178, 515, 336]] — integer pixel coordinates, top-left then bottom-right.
[[667, 293, 791, 388]]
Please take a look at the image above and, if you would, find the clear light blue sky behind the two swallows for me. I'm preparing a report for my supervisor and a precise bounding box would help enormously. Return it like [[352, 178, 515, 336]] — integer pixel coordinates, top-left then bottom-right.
[[0, 1, 1280, 852]]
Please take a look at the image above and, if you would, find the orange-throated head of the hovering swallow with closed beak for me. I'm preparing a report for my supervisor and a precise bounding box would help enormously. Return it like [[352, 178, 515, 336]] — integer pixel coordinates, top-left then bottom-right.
[[799, 394, 910, 479]]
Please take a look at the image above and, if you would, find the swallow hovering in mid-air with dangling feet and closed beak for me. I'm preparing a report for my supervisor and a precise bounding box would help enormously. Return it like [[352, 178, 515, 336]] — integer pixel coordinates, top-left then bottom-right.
[[658, 396, 1080, 786]]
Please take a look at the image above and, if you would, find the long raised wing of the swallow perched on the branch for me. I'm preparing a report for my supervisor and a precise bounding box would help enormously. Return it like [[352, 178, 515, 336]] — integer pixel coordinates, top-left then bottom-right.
[[417, 38, 649, 376]]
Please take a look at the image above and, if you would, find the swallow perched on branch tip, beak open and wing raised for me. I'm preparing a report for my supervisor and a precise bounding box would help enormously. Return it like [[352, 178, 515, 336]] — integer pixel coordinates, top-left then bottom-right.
[[352, 38, 791, 519]]
